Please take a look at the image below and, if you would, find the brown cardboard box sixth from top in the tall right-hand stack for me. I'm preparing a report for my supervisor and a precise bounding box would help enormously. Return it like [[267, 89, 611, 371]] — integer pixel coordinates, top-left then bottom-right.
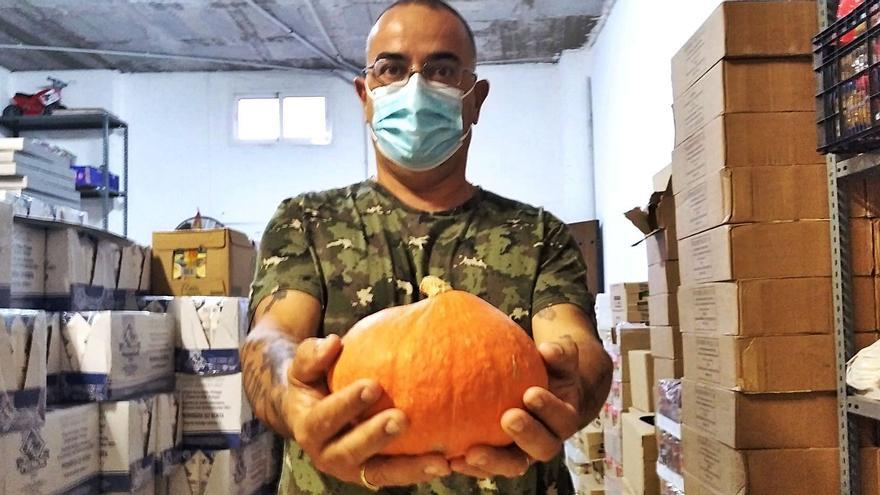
[[678, 277, 834, 337]]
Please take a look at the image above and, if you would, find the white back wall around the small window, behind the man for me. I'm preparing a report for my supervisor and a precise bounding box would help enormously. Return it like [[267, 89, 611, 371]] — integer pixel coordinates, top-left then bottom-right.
[[8, 65, 594, 246]]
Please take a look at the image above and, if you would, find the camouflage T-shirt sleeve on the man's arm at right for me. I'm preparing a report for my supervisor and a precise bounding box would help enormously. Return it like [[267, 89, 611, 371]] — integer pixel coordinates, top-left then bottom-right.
[[532, 214, 595, 322]]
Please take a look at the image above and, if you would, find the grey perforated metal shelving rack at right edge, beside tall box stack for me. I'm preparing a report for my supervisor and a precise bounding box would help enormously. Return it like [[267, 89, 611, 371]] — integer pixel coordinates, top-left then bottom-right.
[[817, 0, 880, 495]]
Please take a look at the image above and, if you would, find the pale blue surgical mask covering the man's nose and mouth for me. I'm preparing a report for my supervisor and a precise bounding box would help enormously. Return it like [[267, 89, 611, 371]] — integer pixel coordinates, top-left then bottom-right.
[[367, 73, 470, 172]]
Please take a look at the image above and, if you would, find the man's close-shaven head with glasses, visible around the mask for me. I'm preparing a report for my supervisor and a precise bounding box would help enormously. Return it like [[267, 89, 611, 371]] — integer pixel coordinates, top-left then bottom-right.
[[355, 0, 489, 181]]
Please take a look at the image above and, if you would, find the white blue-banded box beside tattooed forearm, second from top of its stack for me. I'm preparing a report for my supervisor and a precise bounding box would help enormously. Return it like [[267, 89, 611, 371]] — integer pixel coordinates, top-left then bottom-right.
[[176, 373, 263, 449]]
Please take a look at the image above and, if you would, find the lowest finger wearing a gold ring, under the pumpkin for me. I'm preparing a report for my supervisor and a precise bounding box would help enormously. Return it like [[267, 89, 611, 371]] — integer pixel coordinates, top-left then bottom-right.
[[364, 454, 452, 486]]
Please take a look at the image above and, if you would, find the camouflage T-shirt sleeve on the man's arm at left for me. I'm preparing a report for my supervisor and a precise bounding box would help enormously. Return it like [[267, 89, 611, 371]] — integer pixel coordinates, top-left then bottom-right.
[[249, 198, 324, 324]]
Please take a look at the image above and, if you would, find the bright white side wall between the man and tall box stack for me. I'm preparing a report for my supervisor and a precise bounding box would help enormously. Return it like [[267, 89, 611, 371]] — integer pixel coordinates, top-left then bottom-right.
[[583, 0, 720, 290]]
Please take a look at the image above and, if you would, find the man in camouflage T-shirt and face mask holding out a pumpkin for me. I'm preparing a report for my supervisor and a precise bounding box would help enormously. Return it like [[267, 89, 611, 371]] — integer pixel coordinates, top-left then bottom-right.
[[242, 0, 611, 495]]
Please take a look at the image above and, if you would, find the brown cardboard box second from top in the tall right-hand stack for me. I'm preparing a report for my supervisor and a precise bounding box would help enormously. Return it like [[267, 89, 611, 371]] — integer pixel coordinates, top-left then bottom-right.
[[672, 58, 816, 144]]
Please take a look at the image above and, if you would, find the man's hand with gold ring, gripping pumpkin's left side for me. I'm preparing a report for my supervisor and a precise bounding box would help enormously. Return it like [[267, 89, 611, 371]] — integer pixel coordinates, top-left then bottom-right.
[[283, 335, 451, 486]]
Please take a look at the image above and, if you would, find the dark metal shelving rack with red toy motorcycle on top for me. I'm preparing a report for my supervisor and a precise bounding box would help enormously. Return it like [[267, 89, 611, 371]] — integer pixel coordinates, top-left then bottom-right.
[[0, 110, 128, 236]]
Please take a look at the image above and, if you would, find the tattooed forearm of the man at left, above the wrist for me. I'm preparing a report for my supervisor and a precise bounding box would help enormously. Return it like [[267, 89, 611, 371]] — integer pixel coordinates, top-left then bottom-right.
[[241, 326, 297, 438]]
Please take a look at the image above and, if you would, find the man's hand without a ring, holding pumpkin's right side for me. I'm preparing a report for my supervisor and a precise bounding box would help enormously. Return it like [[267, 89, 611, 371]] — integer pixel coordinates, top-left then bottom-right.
[[452, 305, 611, 478]]
